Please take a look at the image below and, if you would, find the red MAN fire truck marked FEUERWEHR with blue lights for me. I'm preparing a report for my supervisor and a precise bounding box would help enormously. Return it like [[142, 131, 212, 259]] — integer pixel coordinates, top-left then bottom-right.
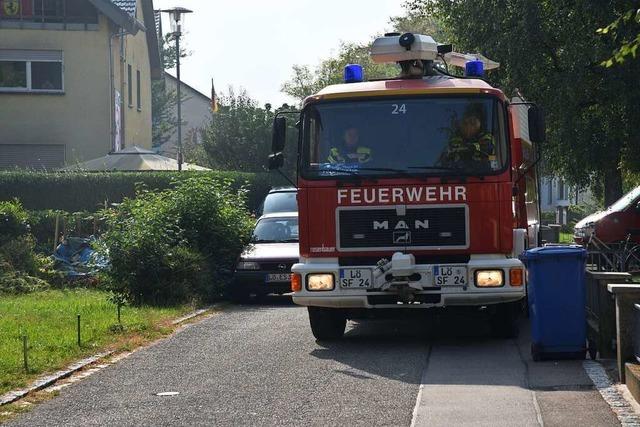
[[269, 33, 544, 340]]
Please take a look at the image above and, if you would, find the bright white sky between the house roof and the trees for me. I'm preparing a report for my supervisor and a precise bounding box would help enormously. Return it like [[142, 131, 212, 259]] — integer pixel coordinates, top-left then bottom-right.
[[153, 0, 403, 106]]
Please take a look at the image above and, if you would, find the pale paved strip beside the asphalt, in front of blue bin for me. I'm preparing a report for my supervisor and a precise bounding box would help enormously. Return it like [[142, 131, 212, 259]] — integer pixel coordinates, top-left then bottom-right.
[[414, 321, 620, 426]]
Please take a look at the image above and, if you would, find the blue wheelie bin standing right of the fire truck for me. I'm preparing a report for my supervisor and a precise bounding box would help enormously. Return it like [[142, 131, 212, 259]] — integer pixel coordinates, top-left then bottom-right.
[[520, 245, 587, 361]]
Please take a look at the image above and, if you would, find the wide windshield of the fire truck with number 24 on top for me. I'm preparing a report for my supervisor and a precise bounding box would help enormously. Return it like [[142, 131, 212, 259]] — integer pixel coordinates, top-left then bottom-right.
[[301, 96, 507, 179]]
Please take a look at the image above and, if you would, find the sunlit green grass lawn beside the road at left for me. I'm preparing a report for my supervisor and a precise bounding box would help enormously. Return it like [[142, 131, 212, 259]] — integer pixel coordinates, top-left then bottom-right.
[[0, 289, 192, 394]]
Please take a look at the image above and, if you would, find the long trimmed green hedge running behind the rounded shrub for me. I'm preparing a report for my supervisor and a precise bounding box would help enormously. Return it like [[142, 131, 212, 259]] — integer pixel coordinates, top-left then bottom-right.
[[0, 171, 286, 212]]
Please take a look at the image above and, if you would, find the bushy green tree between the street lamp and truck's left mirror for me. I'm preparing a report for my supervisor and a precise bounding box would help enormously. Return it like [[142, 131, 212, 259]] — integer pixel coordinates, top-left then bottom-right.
[[203, 88, 297, 173]]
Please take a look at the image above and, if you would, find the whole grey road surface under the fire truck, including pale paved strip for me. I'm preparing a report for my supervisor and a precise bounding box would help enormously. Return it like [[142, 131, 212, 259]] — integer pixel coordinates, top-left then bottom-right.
[[10, 300, 619, 426]]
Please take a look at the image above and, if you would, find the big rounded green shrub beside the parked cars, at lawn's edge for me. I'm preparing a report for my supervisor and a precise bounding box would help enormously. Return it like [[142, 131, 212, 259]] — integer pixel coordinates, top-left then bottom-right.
[[101, 175, 253, 305]]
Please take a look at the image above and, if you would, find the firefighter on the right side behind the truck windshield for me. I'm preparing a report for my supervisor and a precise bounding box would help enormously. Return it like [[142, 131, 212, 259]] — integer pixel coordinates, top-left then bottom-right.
[[442, 104, 496, 168]]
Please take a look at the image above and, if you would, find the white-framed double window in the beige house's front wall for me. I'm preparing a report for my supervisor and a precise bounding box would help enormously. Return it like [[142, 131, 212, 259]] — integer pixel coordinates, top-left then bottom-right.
[[0, 49, 64, 93]]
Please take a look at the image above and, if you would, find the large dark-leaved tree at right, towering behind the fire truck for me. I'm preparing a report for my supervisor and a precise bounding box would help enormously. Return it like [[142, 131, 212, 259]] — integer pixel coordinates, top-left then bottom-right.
[[406, 0, 640, 205]]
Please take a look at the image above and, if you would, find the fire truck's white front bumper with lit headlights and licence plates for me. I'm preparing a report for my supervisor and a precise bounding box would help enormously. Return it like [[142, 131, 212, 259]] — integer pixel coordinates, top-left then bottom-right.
[[292, 253, 526, 309]]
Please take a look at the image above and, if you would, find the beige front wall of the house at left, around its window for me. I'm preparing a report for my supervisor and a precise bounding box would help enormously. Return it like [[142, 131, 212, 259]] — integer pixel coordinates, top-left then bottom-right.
[[0, 16, 111, 162]]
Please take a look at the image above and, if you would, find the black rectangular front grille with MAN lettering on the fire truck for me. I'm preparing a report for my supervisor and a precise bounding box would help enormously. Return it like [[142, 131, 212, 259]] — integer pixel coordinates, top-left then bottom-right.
[[337, 205, 469, 250]]
